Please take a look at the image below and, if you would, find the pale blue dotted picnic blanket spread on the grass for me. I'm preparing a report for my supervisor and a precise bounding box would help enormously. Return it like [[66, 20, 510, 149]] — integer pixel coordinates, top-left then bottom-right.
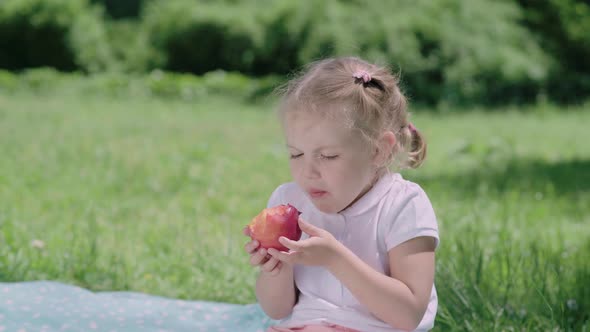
[[0, 281, 277, 332]]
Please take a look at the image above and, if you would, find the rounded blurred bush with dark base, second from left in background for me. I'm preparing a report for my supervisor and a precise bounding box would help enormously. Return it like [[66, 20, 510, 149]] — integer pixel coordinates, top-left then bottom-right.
[[143, 0, 261, 74]]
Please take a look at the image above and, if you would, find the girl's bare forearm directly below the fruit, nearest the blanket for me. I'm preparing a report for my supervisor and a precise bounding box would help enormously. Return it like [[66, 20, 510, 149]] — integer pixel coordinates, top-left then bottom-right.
[[256, 263, 297, 319]]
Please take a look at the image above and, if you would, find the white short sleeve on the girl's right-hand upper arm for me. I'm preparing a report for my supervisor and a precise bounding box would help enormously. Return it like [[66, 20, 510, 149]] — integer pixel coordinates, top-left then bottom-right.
[[385, 184, 439, 251]]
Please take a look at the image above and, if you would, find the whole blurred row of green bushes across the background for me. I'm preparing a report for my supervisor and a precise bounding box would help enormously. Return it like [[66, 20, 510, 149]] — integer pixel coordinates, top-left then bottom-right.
[[0, 0, 590, 104]]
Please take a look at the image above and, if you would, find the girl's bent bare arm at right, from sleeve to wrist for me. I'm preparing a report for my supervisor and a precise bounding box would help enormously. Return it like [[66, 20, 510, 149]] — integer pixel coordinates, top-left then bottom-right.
[[327, 237, 435, 331]]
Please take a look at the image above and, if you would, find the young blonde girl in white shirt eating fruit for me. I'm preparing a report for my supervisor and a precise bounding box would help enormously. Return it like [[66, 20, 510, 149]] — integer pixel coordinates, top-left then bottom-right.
[[245, 58, 439, 332]]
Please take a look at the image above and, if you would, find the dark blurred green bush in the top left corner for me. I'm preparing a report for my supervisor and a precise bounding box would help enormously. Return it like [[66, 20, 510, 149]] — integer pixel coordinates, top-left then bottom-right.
[[0, 0, 113, 72]]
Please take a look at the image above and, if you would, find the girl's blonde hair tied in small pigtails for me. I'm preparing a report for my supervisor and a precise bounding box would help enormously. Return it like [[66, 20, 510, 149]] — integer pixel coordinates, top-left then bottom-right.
[[279, 57, 426, 168]]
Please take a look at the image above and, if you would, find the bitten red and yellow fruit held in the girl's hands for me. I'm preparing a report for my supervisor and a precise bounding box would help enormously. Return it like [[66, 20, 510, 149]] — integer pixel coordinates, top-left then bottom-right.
[[244, 204, 301, 251]]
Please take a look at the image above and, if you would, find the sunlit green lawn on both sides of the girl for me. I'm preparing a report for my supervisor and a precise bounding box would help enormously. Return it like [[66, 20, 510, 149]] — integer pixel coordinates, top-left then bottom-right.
[[0, 89, 590, 331]]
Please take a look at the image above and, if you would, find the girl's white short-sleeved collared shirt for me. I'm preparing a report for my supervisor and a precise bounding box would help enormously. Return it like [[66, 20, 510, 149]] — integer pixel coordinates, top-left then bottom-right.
[[268, 173, 439, 332]]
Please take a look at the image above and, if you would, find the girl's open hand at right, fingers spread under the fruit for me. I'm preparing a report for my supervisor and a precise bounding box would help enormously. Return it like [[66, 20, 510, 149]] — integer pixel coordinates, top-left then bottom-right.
[[268, 218, 345, 266]]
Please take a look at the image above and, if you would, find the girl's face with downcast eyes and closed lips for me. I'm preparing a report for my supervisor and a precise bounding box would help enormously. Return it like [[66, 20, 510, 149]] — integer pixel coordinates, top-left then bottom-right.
[[284, 111, 377, 213]]
